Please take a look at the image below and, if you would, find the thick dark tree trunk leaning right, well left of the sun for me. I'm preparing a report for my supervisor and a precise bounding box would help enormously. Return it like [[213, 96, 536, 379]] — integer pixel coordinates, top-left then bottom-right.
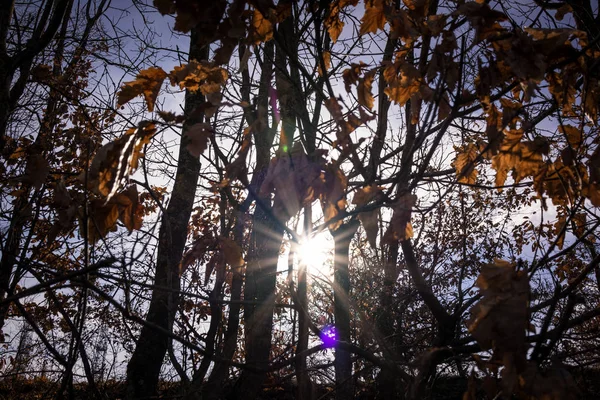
[[127, 31, 208, 399]]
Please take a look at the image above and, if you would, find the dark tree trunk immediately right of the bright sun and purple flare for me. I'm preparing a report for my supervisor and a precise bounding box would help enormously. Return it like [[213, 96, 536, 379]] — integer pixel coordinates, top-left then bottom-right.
[[331, 220, 359, 400]]
